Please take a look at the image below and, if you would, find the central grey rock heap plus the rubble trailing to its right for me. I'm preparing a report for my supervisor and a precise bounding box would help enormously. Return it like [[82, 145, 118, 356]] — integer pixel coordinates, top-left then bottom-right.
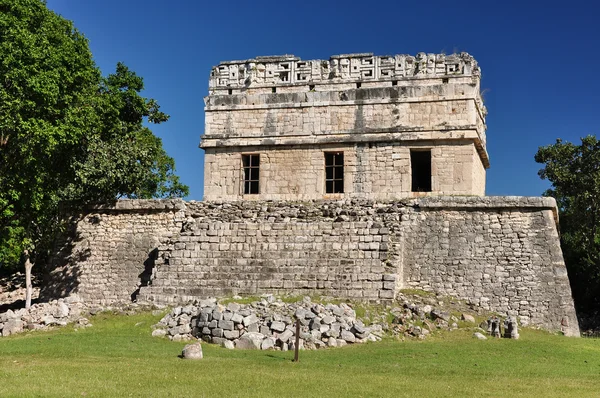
[[152, 294, 518, 351]]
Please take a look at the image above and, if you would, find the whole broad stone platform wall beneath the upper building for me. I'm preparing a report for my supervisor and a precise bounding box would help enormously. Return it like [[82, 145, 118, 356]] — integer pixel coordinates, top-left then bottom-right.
[[45, 197, 578, 334]]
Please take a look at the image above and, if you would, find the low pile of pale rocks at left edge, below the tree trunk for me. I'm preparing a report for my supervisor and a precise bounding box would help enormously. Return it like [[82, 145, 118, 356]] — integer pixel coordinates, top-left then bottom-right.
[[0, 296, 91, 337]]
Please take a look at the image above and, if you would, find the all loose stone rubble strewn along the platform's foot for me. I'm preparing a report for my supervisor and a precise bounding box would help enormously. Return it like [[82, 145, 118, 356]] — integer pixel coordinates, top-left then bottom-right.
[[0, 286, 519, 346]]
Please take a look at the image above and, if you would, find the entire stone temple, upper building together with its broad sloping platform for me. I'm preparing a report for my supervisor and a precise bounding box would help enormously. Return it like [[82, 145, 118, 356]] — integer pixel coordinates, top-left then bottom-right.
[[41, 53, 579, 335]]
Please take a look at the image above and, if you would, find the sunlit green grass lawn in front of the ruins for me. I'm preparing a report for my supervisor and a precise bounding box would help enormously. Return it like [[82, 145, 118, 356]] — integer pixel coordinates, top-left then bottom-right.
[[0, 314, 600, 397]]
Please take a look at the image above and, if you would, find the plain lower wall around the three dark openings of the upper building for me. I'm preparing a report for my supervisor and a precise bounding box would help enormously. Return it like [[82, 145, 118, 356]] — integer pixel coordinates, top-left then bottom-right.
[[204, 140, 485, 200]]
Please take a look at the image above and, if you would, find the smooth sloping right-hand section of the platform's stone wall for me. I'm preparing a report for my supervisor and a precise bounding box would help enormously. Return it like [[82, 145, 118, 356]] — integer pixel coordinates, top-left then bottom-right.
[[404, 201, 574, 329]]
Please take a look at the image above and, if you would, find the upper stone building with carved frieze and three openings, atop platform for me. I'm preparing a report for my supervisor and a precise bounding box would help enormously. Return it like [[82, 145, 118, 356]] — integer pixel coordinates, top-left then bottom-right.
[[200, 53, 489, 200]]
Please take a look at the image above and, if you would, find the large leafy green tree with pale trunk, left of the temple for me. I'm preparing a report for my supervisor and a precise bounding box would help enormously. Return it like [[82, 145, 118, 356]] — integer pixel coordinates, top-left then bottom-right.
[[0, 0, 188, 305]]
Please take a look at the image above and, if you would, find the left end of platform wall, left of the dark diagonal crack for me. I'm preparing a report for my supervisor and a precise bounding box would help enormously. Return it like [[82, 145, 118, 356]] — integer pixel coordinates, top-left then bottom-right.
[[40, 200, 185, 304]]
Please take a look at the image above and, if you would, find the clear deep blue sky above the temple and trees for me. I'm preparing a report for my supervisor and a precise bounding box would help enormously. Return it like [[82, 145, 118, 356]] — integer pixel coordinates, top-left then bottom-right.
[[47, 0, 600, 200]]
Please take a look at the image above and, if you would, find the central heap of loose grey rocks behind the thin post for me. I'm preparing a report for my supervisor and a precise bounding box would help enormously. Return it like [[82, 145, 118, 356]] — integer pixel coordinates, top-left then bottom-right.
[[152, 295, 383, 351]]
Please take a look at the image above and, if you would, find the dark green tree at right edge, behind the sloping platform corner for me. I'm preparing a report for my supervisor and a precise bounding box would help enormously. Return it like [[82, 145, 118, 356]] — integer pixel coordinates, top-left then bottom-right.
[[535, 136, 600, 311]]
